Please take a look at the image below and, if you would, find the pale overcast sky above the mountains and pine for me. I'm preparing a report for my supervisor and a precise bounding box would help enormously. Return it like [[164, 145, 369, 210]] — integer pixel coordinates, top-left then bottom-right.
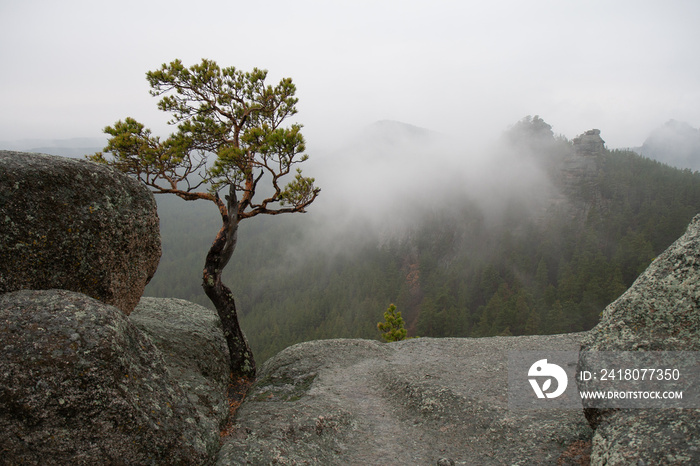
[[0, 0, 700, 148]]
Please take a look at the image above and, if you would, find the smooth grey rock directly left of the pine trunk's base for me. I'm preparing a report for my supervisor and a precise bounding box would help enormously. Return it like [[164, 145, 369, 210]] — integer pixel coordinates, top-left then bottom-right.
[[129, 297, 231, 441]]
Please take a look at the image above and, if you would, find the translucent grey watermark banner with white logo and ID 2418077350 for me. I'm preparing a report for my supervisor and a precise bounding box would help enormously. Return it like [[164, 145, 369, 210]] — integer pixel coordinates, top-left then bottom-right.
[[508, 350, 700, 410]]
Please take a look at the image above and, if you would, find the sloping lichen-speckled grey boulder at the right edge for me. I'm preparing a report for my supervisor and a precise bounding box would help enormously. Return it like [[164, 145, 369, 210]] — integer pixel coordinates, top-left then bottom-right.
[[579, 215, 700, 464]]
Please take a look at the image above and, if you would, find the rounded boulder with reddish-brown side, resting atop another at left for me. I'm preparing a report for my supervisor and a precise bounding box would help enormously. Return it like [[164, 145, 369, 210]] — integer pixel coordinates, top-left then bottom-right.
[[0, 151, 161, 315]]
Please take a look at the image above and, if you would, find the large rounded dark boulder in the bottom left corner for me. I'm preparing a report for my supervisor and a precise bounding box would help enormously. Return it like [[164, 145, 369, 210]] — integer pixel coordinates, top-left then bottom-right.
[[0, 290, 219, 465]]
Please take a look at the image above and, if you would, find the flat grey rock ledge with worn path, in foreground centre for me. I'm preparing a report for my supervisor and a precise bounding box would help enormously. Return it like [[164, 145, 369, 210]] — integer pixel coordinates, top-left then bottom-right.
[[217, 334, 592, 465]]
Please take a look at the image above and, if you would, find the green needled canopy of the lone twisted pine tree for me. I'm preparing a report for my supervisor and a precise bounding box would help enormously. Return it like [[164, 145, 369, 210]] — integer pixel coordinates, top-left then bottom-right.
[[90, 60, 320, 219]]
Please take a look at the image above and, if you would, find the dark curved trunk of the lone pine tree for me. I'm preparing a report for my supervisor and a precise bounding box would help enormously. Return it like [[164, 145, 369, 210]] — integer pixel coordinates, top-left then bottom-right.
[[202, 185, 255, 378]]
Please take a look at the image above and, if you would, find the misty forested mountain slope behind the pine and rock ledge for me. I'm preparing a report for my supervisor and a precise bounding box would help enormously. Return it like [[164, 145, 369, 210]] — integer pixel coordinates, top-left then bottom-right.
[[146, 117, 700, 361]]
